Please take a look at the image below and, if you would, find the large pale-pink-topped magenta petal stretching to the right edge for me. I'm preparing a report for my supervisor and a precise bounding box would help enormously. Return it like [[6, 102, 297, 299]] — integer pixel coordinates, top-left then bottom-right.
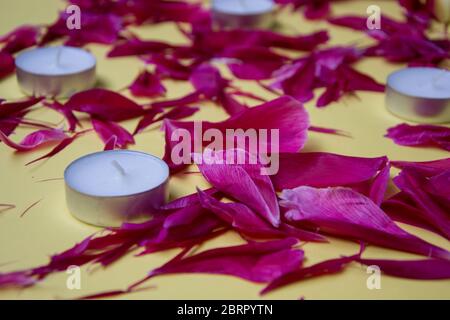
[[280, 187, 450, 260]]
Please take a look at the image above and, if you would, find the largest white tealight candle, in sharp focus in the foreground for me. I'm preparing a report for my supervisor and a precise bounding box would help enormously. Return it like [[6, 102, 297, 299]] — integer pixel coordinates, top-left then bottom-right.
[[64, 150, 169, 227]]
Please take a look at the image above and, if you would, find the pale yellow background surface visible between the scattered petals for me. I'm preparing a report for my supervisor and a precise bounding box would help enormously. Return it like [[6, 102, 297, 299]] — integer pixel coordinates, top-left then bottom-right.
[[0, 0, 450, 299]]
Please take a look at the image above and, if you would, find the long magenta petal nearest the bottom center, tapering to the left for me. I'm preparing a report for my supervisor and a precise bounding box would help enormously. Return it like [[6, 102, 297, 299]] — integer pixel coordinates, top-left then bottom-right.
[[150, 238, 303, 283]]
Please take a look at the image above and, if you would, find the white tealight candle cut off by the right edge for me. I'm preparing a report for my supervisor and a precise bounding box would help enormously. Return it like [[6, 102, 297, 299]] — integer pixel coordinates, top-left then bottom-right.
[[386, 67, 450, 123]]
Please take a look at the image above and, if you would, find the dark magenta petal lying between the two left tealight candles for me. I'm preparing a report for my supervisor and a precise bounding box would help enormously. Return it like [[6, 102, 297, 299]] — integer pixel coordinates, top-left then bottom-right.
[[65, 89, 144, 121]]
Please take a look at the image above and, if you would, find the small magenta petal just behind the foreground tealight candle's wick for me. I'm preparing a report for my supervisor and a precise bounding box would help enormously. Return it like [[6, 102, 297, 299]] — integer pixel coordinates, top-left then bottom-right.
[[92, 119, 134, 150]]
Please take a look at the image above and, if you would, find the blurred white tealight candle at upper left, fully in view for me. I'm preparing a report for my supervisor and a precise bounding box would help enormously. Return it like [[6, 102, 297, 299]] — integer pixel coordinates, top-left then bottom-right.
[[16, 46, 96, 97]]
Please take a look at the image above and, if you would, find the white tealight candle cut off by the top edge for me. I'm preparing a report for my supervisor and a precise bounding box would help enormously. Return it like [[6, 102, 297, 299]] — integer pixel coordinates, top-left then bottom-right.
[[211, 0, 275, 29]]
